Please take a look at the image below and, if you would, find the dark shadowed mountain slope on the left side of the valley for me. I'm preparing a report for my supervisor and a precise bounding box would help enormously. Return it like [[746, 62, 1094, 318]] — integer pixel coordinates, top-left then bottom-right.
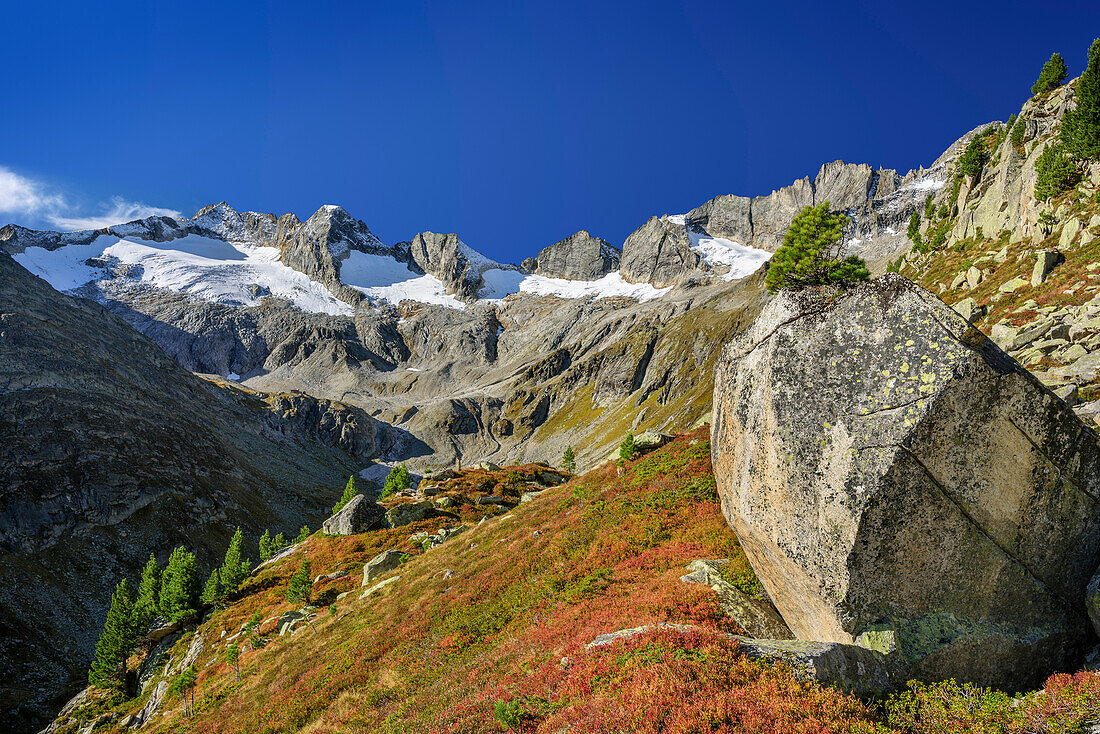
[[0, 254, 392, 731]]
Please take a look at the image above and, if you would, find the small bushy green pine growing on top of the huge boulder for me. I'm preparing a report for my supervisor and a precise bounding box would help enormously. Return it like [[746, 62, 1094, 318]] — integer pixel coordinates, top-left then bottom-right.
[[765, 201, 870, 293]]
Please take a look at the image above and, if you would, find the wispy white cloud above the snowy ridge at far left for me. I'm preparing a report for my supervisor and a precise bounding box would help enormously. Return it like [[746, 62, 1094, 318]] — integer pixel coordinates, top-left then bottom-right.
[[0, 166, 182, 230]]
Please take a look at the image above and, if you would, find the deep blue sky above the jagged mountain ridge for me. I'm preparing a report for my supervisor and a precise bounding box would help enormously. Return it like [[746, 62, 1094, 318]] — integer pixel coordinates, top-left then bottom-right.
[[0, 0, 1100, 261]]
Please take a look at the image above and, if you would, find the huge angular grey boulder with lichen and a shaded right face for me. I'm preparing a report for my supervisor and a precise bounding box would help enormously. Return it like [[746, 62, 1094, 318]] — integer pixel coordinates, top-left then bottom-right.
[[713, 276, 1100, 687]]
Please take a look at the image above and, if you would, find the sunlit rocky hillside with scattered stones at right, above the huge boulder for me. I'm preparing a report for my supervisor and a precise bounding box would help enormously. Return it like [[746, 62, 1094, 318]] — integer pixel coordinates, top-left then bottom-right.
[[893, 81, 1100, 418]]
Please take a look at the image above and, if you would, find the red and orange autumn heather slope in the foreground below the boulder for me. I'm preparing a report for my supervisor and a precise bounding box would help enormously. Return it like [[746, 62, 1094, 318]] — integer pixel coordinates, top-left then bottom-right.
[[81, 429, 1100, 734]]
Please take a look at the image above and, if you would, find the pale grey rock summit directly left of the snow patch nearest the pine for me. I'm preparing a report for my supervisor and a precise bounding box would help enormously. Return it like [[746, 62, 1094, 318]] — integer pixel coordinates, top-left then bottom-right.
[[619, 217, 701, 288]]
